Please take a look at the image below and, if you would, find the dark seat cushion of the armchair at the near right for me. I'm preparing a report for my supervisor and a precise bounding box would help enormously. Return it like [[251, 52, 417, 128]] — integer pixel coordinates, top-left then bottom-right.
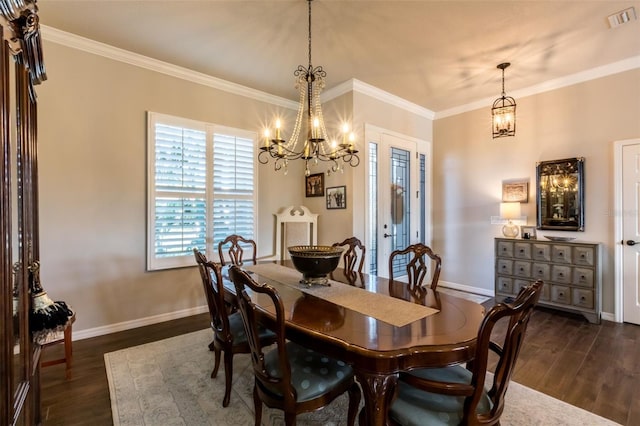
[[389, 366, 492, 426]]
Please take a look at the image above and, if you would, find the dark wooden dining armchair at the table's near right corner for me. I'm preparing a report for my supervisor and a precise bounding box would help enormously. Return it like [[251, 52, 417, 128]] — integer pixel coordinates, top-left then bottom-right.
[[389, 281, 543, 426]]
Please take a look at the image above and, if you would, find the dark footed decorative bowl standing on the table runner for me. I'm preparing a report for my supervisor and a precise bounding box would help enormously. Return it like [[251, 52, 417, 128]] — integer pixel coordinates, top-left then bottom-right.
[[288, 246, 343, 286]]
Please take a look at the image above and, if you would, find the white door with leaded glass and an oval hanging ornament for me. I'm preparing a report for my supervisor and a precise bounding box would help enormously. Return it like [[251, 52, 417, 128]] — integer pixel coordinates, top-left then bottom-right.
[[377, 134, 421, 278]]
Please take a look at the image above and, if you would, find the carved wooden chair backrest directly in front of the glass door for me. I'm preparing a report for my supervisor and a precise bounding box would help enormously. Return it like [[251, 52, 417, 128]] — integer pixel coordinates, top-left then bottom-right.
[[389, 243, 442, 290]]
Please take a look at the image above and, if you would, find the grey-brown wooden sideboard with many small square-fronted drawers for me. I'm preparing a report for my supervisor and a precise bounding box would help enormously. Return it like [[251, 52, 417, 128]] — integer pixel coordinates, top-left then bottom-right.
[[495, 238, 602, 324]]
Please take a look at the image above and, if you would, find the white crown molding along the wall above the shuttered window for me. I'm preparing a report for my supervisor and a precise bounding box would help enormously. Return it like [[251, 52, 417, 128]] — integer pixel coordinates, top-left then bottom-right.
[[40, 25, 298, 110]]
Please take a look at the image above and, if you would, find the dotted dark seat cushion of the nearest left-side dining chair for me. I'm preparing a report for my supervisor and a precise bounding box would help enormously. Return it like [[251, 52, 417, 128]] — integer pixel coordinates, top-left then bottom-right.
[[264, 342, 353, 402]]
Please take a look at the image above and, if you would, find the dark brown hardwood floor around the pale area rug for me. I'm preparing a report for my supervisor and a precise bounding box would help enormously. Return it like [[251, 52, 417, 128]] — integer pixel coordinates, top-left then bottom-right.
[[41, 302, 640, 426]]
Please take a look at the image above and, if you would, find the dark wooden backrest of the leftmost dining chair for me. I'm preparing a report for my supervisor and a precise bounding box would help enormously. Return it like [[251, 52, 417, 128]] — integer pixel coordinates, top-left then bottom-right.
[[193, 248, 233, 342]]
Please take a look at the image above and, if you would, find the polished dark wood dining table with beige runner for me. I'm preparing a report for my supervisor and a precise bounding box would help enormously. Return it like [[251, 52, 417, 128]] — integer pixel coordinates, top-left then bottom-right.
[[223, 261, 485, 426]]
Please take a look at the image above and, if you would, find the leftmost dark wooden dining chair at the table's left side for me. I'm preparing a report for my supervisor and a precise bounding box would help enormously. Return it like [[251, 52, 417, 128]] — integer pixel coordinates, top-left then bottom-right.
[[193, 248, 276, 407]]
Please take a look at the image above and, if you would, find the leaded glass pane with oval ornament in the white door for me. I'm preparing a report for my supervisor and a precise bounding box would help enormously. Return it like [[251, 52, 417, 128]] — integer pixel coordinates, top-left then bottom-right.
[[390, 147, 411, 276]]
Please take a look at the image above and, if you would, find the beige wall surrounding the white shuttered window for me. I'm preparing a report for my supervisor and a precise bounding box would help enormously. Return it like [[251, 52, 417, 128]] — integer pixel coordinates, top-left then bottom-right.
[[37, 42, 304, 332]]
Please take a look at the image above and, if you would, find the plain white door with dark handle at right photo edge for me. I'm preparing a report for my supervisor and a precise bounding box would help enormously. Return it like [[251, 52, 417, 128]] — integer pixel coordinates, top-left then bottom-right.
[[622, 141, 640, 324]]
